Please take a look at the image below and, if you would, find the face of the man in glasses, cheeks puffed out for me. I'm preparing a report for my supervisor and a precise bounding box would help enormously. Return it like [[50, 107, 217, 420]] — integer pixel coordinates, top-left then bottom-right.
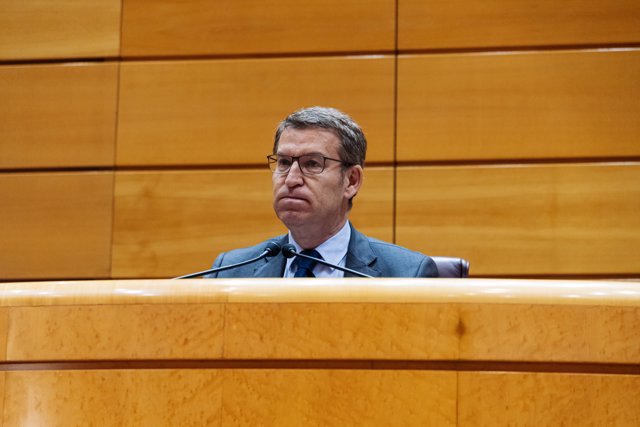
[[273, 128, 359, 233]]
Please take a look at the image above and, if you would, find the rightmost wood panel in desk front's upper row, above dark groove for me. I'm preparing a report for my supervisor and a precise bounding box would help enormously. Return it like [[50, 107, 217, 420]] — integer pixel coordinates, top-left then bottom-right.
[[460, 304, 640, 364]]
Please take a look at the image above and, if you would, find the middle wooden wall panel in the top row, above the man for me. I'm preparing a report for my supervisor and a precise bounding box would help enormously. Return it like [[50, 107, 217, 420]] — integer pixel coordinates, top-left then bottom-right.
[[122, 0, 395, 56]]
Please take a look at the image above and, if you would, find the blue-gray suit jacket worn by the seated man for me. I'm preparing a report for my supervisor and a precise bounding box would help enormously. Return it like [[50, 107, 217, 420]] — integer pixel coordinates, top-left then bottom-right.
[[206, 226, 438, 278]]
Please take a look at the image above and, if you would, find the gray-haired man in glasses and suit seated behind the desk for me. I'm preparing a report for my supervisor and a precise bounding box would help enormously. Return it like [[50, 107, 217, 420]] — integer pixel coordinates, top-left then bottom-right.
[[209, 107, 438, 277]]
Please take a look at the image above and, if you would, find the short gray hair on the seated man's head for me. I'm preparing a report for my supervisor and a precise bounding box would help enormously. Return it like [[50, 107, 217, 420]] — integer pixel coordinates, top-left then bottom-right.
[[273, 107, 367, 167]]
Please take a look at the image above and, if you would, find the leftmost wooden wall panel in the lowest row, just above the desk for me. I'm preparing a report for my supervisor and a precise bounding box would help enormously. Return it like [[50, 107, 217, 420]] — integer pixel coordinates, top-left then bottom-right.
[[0, 172, 113, 280]]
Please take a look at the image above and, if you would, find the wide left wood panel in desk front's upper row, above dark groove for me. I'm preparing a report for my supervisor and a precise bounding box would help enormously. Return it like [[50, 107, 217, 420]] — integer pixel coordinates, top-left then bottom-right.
[[6, 304, 224, 361]]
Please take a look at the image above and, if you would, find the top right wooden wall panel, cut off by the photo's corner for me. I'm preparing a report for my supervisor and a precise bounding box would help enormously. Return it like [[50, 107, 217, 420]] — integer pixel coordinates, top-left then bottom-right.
[[398, 0, 640, 49]]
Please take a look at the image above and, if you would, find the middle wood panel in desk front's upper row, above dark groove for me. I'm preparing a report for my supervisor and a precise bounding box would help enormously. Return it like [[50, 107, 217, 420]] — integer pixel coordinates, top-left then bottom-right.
[[224, 304, 459, 360]]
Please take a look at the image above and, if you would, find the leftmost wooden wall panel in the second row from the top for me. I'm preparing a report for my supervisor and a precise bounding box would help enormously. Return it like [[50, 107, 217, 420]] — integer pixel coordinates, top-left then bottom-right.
[[0, 63, 118, 168]]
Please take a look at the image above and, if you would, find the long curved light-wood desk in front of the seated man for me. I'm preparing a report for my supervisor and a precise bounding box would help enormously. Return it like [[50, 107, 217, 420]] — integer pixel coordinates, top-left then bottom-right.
[[0, 279, 640, 426]]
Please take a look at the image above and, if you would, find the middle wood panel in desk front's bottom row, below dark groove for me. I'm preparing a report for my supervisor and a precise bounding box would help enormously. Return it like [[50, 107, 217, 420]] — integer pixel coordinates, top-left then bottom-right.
[[222, 370, 456, 426]]
